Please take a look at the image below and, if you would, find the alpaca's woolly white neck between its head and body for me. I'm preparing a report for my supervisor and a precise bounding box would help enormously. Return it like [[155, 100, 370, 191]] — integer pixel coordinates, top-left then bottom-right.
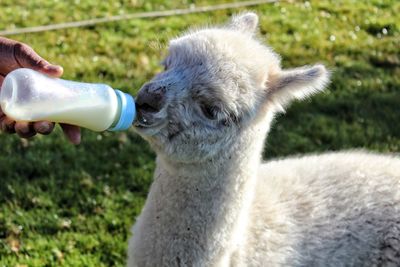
[[137, 126, 264, 266]]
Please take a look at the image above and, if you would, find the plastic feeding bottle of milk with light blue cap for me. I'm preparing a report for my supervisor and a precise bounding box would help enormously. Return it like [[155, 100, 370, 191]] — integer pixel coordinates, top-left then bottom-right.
[[0, 68, 136, 131]]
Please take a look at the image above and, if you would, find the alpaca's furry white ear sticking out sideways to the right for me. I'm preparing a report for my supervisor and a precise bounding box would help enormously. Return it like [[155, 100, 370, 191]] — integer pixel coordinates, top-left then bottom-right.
[[267, 65, 329, 109]]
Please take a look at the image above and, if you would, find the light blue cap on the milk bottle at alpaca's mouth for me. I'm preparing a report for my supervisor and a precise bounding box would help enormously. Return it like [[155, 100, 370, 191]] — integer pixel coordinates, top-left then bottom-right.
[[108, 90, 136, 131]]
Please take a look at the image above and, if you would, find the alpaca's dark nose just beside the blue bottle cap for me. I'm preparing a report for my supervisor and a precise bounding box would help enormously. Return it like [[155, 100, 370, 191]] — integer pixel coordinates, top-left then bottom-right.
[[136, 83, 166, 113]]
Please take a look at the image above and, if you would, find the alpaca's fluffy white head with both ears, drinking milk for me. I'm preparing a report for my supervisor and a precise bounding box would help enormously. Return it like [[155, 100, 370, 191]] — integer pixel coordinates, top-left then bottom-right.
[[135, 13, 328, 162]]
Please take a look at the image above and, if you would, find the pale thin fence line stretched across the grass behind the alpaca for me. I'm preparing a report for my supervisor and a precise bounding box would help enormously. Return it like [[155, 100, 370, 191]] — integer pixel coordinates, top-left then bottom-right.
[[0, 0, 279, 36]]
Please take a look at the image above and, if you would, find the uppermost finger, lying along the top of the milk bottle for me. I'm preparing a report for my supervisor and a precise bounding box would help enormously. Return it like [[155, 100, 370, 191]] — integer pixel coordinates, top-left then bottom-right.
[[14, 43, 63, 77]]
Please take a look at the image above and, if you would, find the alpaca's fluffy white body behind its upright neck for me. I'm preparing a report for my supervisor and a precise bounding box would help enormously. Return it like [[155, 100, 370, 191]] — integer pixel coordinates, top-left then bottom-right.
[[244, 152, 400, 266]]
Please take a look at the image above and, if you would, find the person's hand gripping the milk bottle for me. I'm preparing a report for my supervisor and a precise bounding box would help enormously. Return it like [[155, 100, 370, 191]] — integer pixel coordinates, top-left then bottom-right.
[[0, 37, 81, 144]]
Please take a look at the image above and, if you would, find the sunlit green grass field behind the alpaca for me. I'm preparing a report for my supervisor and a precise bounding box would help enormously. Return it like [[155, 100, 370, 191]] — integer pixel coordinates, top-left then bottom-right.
[[0, 0, 400, 267]]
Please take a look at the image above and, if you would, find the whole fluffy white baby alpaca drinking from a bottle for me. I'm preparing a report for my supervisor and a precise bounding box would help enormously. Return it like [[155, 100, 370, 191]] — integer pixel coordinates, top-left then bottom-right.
[[128, 13, 400, 267]]
